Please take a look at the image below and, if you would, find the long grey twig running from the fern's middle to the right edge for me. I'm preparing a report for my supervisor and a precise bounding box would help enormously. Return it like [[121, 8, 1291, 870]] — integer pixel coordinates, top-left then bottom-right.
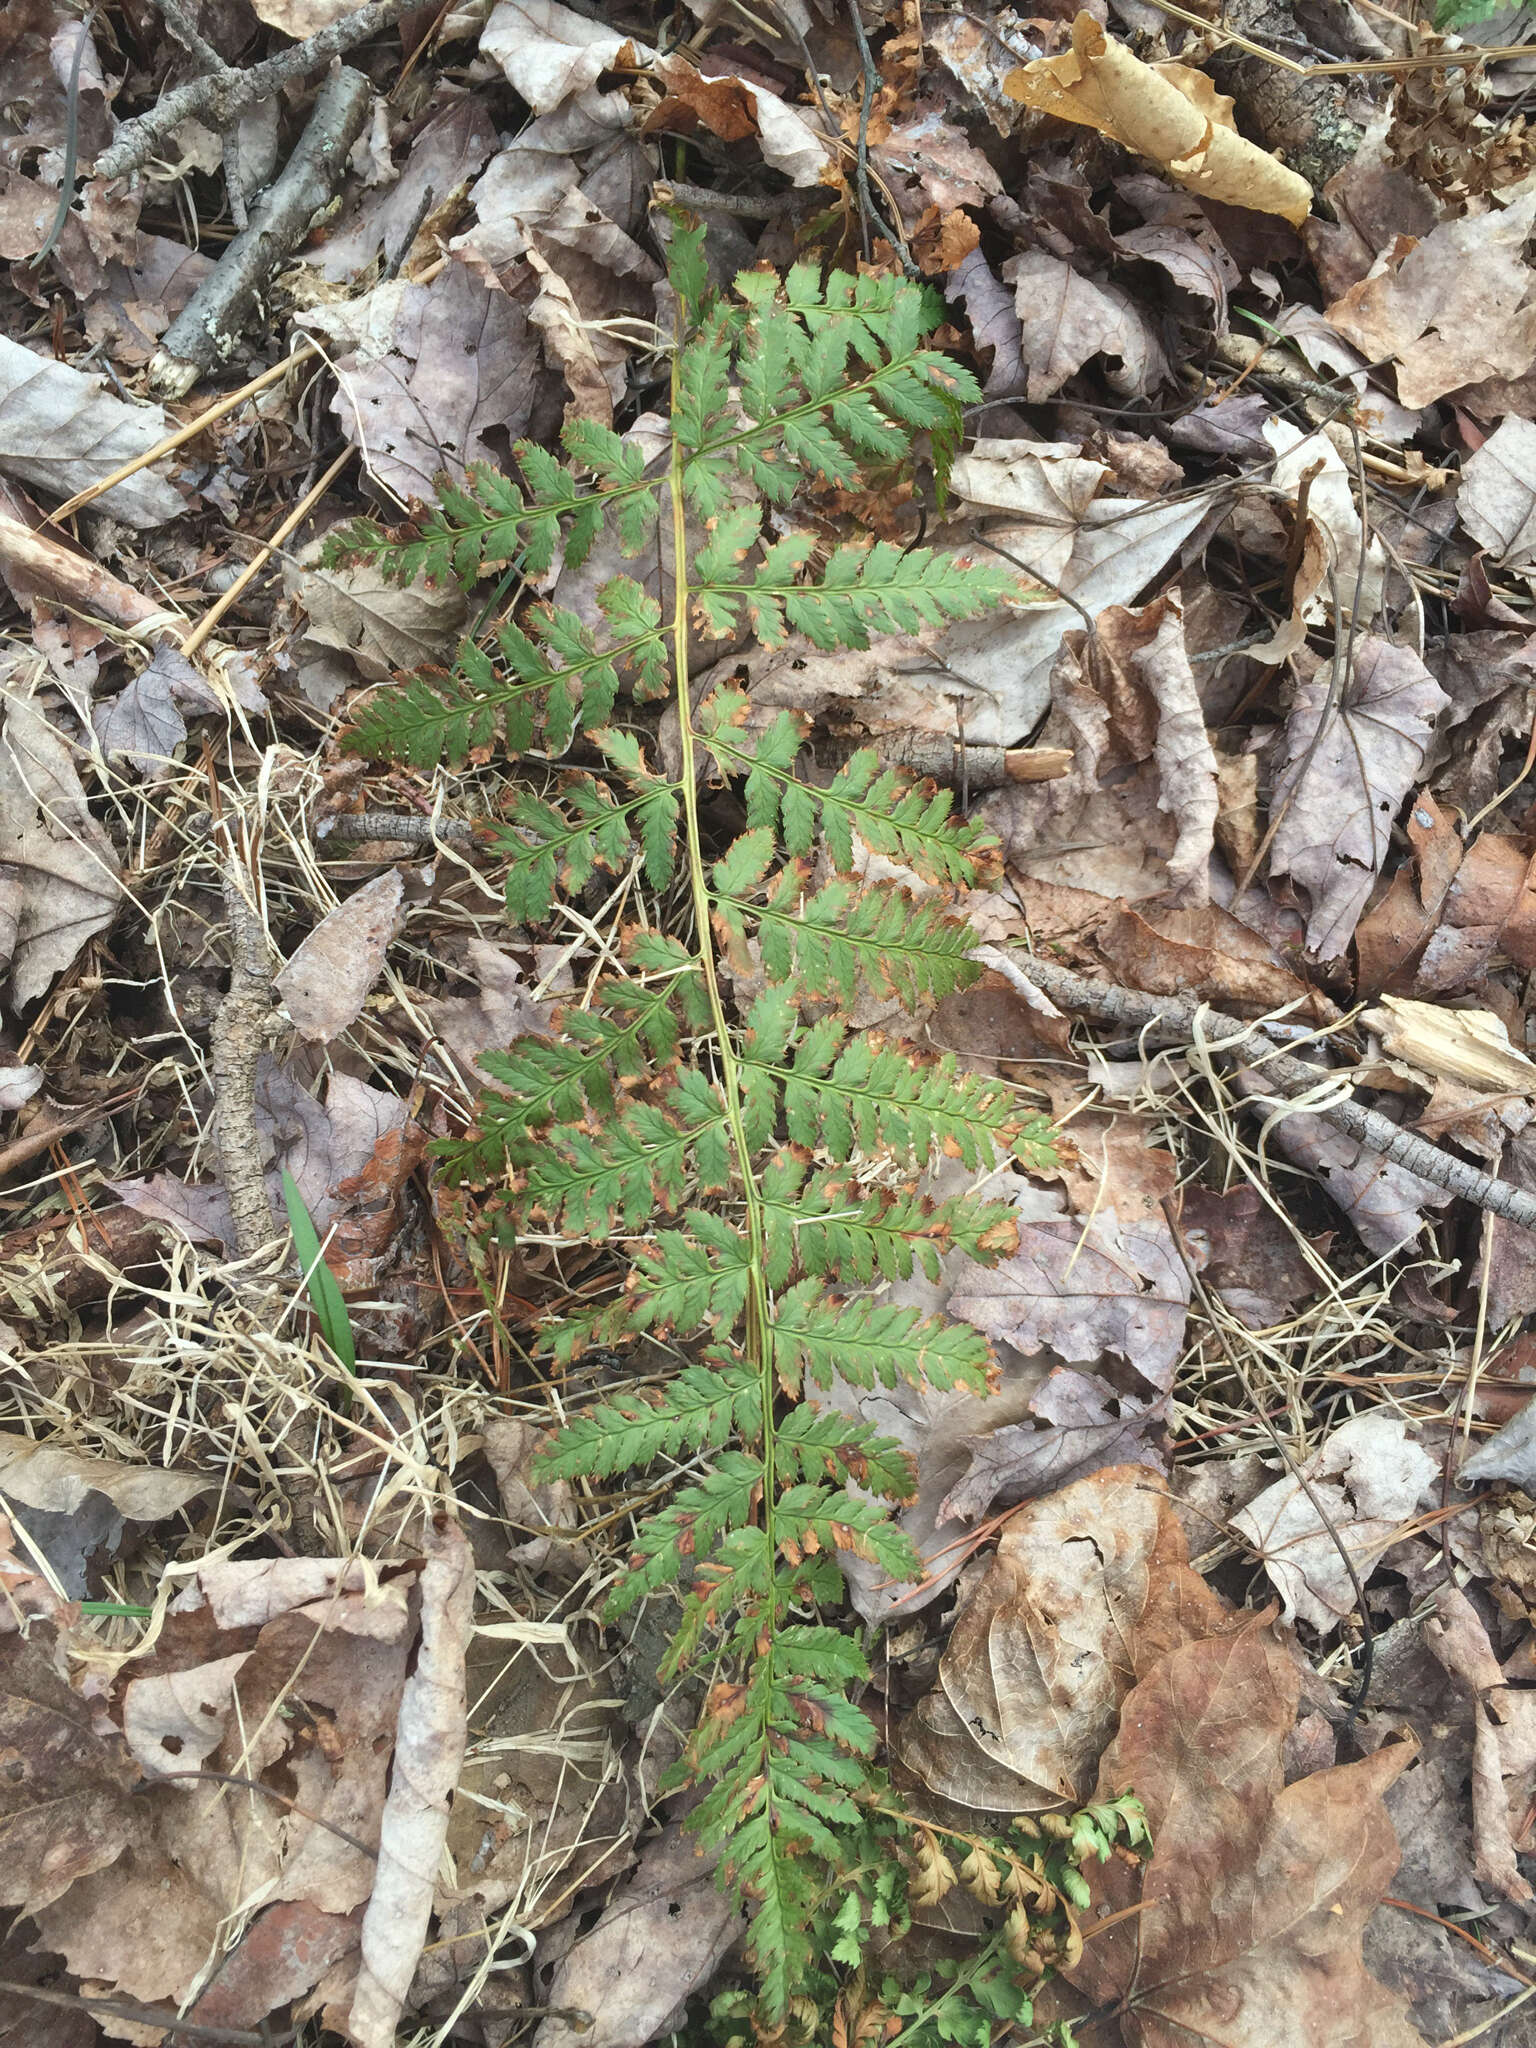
[[971, 946, 1536, 1231]]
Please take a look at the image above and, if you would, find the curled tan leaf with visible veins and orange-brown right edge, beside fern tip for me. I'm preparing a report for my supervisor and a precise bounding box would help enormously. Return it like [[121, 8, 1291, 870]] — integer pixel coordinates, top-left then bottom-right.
[[897, 1466, 1227, 1812]]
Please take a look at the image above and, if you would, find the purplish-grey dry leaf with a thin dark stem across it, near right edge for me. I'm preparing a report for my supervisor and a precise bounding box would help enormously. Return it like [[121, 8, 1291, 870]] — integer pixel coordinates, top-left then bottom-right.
[[1270, 633, 1450, 961]]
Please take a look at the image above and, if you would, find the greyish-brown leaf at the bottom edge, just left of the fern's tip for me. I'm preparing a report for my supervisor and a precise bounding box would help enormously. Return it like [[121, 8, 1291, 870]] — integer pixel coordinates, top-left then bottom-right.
[[535, 1821, 741, 2048]]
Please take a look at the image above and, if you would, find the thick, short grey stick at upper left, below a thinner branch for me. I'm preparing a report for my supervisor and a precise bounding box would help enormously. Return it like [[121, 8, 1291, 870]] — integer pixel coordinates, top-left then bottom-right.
[[150, 66, 373, 397]]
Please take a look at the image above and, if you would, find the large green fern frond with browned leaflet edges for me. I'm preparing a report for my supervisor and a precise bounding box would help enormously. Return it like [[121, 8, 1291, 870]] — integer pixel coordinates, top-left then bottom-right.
[[334, 223, 1051, 2025]]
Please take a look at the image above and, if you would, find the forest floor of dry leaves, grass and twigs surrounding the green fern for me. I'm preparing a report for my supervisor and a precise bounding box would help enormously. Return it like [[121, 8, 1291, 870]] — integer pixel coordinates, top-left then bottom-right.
[[0, 0, 1536, 2048]]
